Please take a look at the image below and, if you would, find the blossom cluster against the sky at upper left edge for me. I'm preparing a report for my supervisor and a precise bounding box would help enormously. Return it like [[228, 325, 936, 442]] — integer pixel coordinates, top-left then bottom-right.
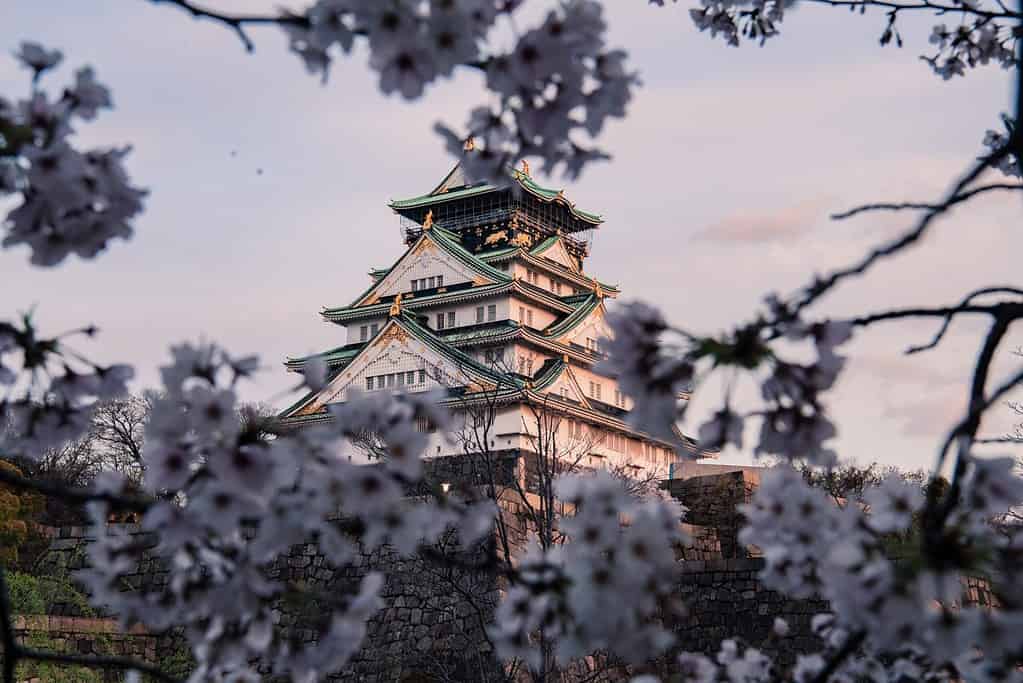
[[0, 43, 145, 266]]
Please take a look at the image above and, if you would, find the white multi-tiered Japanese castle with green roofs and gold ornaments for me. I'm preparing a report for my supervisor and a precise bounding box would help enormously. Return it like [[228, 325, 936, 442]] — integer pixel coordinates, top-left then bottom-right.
[[280, 150, 703, 477]]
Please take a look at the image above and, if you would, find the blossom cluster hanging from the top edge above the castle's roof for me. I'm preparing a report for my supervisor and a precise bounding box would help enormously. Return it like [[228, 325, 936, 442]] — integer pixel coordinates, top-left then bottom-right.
[[281, 0, 637, 180]]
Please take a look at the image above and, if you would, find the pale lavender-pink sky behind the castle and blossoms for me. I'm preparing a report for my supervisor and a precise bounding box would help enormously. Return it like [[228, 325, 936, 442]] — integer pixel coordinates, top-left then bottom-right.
[[0, 0, 1023, 467]]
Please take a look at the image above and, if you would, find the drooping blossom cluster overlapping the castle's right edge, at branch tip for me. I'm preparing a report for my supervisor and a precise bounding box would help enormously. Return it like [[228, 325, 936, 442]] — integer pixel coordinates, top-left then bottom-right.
[[605, 297, 852, 464]]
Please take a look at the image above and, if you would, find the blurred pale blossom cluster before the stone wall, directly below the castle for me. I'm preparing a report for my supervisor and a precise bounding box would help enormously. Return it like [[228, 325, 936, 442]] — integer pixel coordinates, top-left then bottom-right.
[[491, 471, 687, 669]]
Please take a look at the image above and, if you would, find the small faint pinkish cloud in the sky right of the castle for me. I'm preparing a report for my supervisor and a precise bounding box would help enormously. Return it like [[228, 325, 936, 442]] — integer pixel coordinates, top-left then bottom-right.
[[694, 198, 834, 244]]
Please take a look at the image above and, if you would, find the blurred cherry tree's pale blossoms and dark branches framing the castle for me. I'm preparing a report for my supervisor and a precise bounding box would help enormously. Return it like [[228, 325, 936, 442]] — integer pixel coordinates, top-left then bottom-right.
[[0, 0, 1023, 683]]
